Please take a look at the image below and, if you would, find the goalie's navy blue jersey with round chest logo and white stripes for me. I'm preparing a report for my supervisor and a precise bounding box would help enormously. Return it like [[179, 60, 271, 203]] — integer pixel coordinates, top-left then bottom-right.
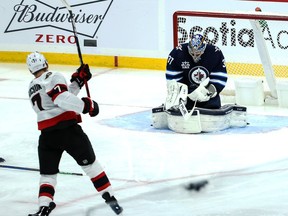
[[166, 43, 227, 94]]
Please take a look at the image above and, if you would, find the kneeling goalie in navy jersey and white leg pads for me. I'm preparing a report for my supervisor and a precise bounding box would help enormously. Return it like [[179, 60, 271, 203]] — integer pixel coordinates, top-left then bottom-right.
[[152, 34, 247, 133]]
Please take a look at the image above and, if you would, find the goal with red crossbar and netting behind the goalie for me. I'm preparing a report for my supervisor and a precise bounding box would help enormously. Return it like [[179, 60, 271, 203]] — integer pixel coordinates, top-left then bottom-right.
[[173, 11, 288, 97]]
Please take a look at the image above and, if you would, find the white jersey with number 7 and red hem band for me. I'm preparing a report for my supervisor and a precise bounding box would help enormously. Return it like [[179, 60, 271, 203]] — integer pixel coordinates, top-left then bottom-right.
[[28, 71, 84, 130]]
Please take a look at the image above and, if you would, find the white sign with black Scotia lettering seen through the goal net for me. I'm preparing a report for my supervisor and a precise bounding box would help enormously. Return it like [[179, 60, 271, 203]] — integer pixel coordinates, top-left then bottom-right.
[[178, 17, 288, 50]]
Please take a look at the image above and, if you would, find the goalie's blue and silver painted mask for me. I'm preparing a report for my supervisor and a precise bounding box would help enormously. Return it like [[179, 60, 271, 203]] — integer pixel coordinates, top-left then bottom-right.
[[188, 34, 206, 63]]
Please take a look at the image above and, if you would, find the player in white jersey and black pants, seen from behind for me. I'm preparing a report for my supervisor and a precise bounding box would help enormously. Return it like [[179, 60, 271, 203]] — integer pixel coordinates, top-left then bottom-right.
[[27, 52, 123, 216]]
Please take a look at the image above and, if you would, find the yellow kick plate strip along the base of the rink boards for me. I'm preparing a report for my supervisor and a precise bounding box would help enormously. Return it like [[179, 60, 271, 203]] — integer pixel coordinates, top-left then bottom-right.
[[0, 51, 288, 78]]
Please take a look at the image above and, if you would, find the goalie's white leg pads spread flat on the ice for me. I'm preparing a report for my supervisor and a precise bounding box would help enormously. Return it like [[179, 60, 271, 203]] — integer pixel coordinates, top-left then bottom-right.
[[152, 104, 248, 134]]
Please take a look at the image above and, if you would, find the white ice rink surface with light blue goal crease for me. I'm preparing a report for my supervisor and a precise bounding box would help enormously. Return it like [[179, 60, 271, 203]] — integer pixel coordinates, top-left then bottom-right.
[[0, 64, 288, 216]]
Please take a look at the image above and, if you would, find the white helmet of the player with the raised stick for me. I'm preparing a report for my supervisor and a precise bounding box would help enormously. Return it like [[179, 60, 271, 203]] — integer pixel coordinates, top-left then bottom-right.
[[26, 52, 48, 74]]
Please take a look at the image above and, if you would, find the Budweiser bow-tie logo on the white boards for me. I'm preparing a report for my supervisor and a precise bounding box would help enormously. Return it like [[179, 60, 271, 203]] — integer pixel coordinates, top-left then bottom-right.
[[5, 0, 113, 38]]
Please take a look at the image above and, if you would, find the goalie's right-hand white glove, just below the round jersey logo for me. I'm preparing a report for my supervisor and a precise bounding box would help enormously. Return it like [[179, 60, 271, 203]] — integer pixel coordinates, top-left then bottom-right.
[[188, 78, 217, 102]]
